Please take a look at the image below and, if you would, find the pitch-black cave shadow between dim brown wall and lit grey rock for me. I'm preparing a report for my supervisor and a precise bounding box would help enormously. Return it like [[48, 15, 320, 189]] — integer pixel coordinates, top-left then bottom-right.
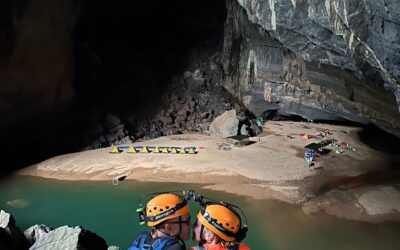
[[0, 0, 226, 174]]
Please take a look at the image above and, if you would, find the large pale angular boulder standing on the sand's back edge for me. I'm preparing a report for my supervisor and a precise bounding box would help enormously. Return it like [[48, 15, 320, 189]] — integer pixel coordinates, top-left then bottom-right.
[[209, 110, 239, 138]]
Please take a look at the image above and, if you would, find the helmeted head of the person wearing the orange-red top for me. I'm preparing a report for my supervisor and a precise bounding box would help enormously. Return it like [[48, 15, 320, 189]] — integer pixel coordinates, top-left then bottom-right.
[[193, 203, 245, 244]]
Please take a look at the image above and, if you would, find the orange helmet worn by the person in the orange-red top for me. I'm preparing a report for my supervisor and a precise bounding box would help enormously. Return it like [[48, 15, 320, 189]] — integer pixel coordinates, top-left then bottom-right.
[[197, 204, 242, 242]]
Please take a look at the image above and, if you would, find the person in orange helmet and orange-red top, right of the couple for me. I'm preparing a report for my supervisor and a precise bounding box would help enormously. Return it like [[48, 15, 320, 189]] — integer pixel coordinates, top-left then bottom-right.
[[190, 202, 250, 250]]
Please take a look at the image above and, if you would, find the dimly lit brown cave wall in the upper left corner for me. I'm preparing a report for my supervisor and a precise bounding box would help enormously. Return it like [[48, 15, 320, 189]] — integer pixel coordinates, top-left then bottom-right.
[[0, 0, 79, 126]]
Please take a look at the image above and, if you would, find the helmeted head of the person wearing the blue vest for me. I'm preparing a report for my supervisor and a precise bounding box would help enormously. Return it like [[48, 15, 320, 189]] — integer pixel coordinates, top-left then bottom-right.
[[145, 193, 190, 240]]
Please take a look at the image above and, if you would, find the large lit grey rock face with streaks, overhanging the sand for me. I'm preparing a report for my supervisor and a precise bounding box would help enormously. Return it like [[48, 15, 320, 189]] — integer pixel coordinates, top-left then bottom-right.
[[223, 0, 400, 135]]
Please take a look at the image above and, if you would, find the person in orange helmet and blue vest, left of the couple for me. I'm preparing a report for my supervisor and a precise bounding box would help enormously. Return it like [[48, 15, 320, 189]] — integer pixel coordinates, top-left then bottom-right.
[[128, 193, 191, 250]]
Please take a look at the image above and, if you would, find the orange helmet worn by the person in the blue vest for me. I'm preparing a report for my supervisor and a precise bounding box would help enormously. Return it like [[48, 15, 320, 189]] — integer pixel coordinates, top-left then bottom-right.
[[144, 193, 189, 227]]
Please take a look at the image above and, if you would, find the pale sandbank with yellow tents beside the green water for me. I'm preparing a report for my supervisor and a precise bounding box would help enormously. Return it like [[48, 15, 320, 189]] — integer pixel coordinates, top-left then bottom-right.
[[19, 121, 400, 222]]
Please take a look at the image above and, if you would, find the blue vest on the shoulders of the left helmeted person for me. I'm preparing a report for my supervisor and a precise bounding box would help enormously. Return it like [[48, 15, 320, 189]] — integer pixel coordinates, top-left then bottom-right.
[[128, 232, 181, 250]]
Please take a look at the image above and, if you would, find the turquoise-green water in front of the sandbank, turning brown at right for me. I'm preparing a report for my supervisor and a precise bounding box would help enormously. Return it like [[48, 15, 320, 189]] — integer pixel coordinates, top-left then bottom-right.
[[0, 176, 400, 250]]
